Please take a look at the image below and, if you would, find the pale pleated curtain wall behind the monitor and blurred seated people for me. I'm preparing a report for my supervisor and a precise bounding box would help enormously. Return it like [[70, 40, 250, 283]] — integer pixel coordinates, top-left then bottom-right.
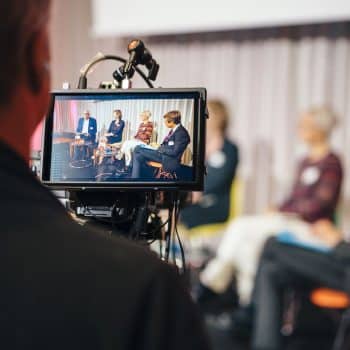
[[47, 0, 350, 227]]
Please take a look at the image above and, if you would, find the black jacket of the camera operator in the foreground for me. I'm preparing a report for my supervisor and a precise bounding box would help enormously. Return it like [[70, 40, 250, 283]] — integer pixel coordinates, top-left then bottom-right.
[[0, 140, 209, 350]]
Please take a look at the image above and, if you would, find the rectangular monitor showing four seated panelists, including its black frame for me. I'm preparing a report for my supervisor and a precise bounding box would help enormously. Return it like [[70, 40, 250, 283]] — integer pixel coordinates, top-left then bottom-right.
[[42, 88, 206, 190]]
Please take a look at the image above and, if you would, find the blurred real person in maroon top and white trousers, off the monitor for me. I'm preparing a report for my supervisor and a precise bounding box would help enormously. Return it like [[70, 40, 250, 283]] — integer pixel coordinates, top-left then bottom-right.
[[196, 107, 343, 304]]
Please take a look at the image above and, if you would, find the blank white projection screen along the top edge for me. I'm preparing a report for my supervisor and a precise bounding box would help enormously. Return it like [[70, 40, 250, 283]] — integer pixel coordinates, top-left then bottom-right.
[[92, 0, 350, 37]]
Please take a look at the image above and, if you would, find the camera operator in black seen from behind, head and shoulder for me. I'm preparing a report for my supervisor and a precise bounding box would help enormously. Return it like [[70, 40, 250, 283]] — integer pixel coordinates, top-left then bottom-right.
[[0, 0, 208, 350]]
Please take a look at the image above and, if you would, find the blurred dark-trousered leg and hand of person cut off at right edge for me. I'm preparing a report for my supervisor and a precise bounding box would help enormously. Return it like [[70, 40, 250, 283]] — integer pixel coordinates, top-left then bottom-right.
[[253, 220, 350, 350]]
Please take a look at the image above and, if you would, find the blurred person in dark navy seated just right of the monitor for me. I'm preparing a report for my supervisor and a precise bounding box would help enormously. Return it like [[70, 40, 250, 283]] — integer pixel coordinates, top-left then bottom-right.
[[181, 100, 238, 228]]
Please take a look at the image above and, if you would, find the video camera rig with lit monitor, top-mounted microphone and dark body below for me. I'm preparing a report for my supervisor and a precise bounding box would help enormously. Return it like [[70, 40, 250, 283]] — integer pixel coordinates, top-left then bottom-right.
[[41, 40, 207, 266]]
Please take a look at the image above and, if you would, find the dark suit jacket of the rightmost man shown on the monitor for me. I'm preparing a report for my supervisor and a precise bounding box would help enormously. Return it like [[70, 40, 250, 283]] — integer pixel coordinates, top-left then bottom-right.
[[158, 125, 191, 171]]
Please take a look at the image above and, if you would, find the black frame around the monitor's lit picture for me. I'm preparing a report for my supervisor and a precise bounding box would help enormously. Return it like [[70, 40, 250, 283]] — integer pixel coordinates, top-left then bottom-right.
[[41, 88, 207, 191]]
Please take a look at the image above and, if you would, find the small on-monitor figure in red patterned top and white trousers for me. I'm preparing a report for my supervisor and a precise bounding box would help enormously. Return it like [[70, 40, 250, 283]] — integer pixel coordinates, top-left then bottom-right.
[[121, 111, 153, 167]]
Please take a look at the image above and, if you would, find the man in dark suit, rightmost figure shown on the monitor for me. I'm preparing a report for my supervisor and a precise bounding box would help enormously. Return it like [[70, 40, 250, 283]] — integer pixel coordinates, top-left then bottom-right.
[[131, 111, 190, 179]]
